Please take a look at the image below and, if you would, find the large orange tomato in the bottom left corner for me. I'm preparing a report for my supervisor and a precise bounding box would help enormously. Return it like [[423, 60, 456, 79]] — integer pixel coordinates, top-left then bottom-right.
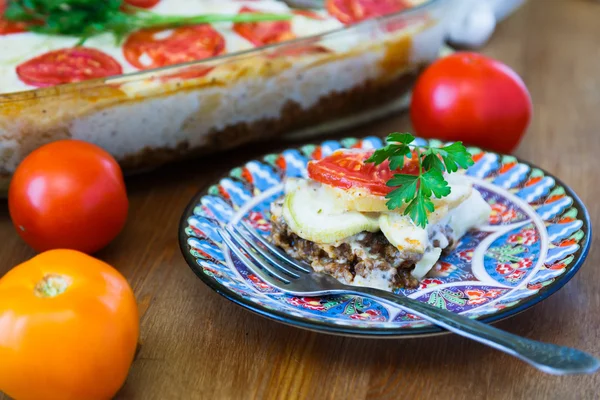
[[0, 250, 139, 400]]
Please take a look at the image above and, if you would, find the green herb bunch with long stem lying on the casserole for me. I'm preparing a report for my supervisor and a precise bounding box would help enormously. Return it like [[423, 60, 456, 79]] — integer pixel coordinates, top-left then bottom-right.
[[4, 0, 291, 45]]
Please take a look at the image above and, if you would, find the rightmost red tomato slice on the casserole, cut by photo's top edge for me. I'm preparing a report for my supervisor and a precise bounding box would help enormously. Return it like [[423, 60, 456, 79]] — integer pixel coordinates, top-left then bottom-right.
[[325, 0, 409, 24]]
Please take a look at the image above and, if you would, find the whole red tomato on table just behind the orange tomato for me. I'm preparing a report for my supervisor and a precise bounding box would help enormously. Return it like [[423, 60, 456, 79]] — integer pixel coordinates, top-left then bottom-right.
[[8, 140, 128, 253]]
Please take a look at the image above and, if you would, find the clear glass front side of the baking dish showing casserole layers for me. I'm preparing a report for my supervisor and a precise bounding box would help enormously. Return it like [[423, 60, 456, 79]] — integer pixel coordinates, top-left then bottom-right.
[[0, 0, 453, 191]]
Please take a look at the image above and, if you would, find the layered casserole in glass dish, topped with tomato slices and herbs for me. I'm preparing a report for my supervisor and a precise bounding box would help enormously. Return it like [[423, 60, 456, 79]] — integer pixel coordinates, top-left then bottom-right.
[[0, 0, 451, 194]]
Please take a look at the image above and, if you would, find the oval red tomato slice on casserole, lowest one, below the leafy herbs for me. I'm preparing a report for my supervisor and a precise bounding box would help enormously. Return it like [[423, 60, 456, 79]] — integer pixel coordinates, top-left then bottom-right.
[[17, 47, 123, 87]]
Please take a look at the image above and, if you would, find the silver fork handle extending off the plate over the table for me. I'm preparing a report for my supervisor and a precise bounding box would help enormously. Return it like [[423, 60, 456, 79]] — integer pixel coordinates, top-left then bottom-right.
[[352, 288, 600, 375]]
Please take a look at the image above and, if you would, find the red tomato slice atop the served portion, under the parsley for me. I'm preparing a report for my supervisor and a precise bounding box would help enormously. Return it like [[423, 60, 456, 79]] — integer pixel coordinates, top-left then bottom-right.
[[308, 150, 419, 196]]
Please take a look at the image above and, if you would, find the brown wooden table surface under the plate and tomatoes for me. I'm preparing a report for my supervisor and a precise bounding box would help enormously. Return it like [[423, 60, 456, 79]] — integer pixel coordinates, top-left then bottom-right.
[[0, 0, 600, 399]]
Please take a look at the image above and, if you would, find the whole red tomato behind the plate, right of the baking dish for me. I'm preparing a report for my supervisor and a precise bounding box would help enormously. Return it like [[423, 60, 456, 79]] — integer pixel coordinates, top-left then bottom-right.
[[410, 52, 532, 153]]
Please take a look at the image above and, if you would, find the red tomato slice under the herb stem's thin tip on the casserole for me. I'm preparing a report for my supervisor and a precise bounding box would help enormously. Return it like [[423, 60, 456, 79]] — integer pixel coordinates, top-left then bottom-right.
[[233, 6, 296, 46]]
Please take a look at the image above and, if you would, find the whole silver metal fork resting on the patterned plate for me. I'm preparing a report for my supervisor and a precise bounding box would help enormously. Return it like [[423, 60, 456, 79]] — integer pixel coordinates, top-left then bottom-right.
[[220, 221, 600, 375]]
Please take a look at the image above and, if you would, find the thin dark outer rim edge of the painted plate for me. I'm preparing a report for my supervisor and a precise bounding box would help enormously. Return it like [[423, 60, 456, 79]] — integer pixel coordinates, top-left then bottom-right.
[[178, 136, 592, 338]]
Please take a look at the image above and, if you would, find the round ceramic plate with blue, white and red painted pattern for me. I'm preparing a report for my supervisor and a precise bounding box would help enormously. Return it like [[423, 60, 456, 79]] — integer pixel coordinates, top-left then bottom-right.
[[179, 137, 591, 336]]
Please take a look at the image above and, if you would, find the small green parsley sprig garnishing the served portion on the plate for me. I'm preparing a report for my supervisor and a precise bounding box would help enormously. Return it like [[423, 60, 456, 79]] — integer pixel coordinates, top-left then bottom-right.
[[366, 132, 473, 228]]
